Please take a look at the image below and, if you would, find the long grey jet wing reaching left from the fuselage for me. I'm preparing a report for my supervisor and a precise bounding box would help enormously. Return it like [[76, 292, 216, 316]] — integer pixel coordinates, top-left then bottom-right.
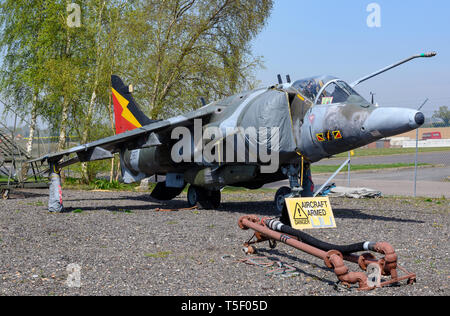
[[28, 104, 221, 168]]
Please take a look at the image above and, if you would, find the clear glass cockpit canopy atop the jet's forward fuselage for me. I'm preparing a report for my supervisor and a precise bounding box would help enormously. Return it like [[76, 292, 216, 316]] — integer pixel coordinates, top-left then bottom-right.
[[292, 76, 369, 104]]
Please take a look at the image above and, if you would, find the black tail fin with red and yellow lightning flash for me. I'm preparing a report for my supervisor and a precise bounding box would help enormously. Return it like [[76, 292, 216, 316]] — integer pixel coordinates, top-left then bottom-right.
[[111, 75, 155, 134]]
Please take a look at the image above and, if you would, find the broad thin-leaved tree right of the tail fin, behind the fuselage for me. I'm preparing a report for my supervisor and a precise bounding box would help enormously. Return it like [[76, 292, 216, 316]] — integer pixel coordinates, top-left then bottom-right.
[[122, 0, 273, 119]]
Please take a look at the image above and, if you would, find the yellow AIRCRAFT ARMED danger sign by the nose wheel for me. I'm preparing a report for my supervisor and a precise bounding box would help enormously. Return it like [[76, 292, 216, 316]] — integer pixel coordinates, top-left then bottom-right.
[[286, 197, 336, 229]]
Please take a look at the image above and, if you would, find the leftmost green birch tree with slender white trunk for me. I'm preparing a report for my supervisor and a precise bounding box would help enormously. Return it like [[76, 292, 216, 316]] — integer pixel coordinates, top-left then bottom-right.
[[0, 0, 50, 155]]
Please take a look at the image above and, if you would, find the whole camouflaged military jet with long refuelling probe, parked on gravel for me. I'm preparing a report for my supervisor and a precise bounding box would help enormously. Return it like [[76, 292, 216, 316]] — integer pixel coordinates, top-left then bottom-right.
[[36, 53, 436, 212]]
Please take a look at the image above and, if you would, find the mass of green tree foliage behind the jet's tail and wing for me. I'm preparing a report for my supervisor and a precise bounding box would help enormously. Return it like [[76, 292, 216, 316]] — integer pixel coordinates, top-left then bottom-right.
[[0, 0, 273, 183]]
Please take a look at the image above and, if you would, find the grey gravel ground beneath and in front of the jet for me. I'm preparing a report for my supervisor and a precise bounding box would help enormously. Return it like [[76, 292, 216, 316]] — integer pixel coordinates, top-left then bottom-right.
[[0, 190, 450, 296]]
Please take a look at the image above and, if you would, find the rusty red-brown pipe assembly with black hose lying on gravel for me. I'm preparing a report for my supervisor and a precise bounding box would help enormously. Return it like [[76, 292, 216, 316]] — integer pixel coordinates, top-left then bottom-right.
[[239, 216, 416, 291]]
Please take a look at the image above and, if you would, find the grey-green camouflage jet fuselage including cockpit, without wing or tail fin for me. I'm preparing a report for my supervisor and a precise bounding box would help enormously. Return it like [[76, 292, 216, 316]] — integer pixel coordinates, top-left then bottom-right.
[[122, 77, 423, 190]]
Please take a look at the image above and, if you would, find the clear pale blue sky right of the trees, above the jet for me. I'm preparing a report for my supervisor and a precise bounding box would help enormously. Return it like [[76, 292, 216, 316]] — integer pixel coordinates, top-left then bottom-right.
[[253, 0, 450, 117]]
